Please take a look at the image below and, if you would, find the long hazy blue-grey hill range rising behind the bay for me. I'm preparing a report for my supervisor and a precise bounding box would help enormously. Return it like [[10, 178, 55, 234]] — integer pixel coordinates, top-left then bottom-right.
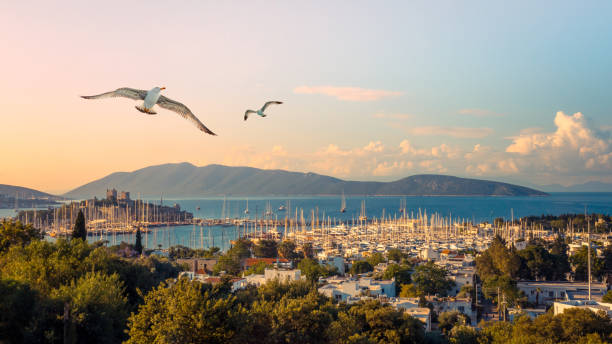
[[64, 163, 546, 198]]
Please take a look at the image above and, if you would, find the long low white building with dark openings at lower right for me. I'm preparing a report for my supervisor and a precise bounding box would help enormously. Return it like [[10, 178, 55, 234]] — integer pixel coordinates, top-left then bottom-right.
[[516, 281, 608, 305]]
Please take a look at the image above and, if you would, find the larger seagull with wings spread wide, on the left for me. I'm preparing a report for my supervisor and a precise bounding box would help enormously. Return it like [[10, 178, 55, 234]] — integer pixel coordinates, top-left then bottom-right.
[[81, 87, 216, 135]]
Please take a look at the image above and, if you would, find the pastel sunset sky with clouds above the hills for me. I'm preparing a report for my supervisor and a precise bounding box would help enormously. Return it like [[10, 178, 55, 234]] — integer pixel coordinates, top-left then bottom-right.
[[0, 0, 612, 193]]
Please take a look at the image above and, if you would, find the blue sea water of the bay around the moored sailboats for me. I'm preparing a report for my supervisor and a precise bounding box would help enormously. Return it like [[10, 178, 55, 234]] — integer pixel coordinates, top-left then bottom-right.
[[0, 192, 612, 250]]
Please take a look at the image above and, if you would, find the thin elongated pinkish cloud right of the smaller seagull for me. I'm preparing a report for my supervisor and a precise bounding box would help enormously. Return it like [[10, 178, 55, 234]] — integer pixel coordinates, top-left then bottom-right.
[[293, 86, 402, 102]]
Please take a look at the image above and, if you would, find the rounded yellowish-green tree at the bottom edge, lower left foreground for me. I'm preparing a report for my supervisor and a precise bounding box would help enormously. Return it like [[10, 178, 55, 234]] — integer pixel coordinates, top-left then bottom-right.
[[52, 273, 128, 343]]
